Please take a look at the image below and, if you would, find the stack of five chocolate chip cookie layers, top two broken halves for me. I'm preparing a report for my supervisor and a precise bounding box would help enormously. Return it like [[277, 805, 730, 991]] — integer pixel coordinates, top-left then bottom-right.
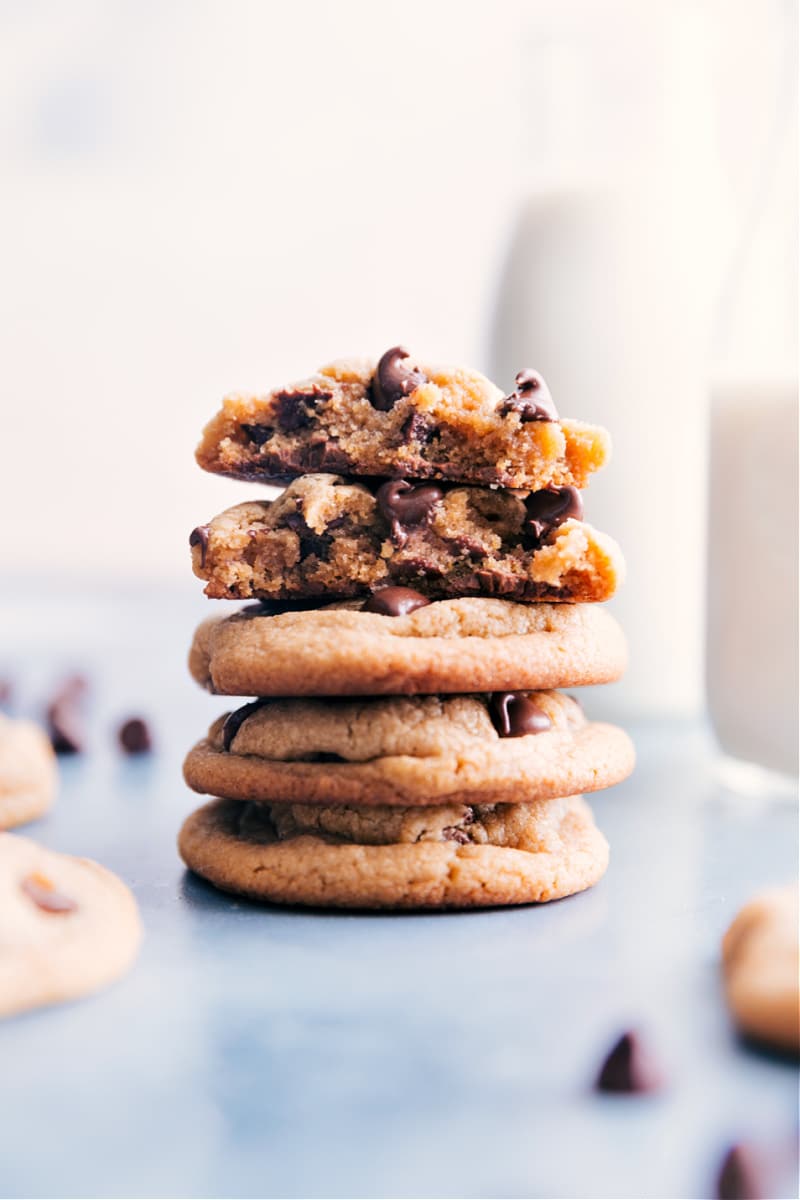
[[179, 347, 633, 908]]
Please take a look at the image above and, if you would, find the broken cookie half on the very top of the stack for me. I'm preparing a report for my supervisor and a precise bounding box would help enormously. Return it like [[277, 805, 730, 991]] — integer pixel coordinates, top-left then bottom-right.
[[197, 347, 610, 490]]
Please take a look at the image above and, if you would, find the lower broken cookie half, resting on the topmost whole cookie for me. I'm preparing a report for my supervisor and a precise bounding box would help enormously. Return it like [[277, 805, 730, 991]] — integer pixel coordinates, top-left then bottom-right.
[[191, 475, 624, 602]]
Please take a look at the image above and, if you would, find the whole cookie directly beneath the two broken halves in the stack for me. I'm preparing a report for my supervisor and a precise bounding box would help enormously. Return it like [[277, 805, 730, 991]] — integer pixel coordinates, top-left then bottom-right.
[[190, 597, 627, 696]]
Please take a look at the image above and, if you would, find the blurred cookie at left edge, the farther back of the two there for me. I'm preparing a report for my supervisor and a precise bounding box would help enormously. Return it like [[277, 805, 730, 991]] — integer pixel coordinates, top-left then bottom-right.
[[0, 714, 59, 829]]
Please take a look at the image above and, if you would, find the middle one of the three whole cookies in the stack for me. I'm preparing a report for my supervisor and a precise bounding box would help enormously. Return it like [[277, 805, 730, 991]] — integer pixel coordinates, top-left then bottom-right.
[[184, 691, 634, 806]]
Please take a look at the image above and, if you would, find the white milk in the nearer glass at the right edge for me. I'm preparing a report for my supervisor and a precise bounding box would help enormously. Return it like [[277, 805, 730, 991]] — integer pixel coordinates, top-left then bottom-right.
[[706, 379, 798, 774]]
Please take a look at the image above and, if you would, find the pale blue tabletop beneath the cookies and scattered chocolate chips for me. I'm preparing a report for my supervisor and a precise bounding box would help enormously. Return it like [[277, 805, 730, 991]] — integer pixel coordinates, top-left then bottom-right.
[[0, 593, 798, 1198]]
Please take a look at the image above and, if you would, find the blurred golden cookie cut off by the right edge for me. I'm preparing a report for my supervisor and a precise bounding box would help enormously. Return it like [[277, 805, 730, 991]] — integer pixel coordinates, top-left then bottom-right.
[[722, 887, 800, 1052]]
